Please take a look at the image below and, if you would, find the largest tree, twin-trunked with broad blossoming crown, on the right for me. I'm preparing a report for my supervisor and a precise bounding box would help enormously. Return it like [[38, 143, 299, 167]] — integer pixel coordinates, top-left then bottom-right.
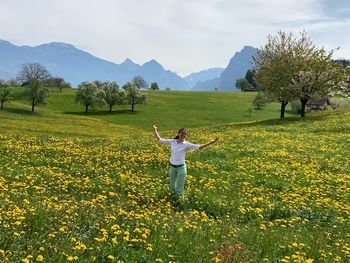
[[254, 31, 342, 118]]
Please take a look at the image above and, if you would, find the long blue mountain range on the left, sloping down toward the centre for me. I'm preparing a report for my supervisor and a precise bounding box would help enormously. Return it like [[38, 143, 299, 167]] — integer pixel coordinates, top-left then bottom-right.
[[0, 40, 189, 90]]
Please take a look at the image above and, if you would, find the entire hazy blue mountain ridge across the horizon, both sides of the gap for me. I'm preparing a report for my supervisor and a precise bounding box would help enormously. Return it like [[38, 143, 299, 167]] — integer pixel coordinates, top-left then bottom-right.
[[0, 40, 257, 91]]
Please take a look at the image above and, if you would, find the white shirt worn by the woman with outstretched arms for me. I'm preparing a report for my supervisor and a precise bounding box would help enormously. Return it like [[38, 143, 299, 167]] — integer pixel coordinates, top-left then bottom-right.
[[159, 138, 200, 165]]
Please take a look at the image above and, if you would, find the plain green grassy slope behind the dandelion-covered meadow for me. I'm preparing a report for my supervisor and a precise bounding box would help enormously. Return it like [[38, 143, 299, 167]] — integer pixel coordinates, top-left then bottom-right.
[[7, 89, 296, 133]]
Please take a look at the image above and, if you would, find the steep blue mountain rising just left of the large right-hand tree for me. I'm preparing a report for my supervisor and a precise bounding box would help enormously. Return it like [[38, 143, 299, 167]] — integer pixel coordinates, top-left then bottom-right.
[[192, 46, 257, 91]]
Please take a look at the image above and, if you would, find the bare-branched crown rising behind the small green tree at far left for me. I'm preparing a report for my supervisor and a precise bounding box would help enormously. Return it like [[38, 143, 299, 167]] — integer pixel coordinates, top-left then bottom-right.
[[17, 63, 50, 84]]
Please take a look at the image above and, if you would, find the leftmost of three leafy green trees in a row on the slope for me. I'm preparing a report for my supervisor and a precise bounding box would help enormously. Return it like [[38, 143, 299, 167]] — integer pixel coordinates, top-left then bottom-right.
[[75, 82, 105, 113]]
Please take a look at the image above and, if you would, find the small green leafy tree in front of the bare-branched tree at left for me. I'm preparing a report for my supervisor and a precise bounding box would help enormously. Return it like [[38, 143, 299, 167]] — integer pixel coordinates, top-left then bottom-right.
[[26, 79, 49, 112]]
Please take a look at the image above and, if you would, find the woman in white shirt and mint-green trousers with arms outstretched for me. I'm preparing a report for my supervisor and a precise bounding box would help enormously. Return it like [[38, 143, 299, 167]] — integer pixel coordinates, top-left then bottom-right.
[[153, 124, 219, 196]]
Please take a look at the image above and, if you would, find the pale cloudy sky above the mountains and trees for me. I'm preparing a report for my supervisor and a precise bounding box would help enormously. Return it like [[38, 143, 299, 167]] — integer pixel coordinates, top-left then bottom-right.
[[0, 0, 350, 77]]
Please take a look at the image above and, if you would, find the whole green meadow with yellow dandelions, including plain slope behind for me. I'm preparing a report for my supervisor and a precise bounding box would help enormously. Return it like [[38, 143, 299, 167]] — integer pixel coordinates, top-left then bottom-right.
[[0, 91, 350, 262]]
